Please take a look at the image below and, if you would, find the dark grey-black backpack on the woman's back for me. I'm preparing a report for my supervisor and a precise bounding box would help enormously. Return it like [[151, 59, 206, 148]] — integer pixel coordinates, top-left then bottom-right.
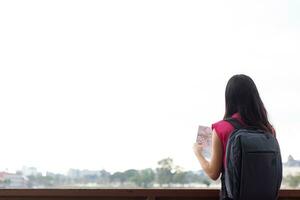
[[221, 118, 282, 200]]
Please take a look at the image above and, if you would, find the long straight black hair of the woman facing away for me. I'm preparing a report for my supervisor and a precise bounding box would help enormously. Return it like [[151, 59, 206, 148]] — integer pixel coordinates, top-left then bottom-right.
[[224, 74, 275, 135]]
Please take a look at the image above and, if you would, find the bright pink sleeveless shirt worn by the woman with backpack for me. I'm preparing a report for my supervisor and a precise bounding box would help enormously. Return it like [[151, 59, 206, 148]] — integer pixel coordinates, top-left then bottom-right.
[[211, 113, 244, 166]]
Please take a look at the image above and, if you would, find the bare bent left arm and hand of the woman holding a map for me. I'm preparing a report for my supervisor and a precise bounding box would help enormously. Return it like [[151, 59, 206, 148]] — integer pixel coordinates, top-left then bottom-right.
[[193, 129, 223, 180]]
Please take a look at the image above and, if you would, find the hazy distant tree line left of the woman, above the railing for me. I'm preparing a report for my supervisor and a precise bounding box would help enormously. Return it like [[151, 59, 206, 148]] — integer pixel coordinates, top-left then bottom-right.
[[0, 158, 212, 188]]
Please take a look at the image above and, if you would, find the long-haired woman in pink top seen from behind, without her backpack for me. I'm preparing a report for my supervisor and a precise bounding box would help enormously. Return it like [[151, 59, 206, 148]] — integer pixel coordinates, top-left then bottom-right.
[[193, 75, 275, 197]]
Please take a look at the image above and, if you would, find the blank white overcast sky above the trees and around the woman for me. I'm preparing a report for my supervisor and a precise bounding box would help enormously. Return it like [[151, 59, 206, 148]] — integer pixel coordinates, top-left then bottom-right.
[[0, 0, 300, 172]]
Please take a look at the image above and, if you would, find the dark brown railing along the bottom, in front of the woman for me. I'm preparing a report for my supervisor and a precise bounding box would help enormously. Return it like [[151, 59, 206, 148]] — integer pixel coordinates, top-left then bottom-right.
[[0, 189, 300, 200]]
